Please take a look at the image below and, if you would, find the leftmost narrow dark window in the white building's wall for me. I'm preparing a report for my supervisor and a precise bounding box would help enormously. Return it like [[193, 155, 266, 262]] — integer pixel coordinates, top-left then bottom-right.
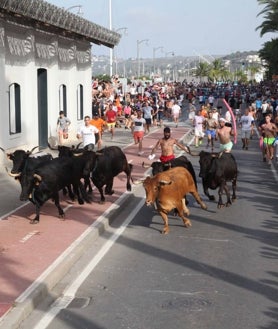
[[9, 83, 21, 135]]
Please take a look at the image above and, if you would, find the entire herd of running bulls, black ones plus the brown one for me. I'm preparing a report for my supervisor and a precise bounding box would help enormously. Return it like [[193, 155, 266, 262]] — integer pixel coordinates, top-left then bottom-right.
[[0, 146, 238, 234]]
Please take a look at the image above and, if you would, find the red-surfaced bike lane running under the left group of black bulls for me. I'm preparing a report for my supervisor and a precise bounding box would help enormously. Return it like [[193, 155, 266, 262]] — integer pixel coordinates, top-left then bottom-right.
[[0, 127, 190, 320]]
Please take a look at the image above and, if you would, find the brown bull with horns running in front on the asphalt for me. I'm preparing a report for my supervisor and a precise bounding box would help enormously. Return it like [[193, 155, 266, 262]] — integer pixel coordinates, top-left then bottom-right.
[[143, 167, 207, 234]]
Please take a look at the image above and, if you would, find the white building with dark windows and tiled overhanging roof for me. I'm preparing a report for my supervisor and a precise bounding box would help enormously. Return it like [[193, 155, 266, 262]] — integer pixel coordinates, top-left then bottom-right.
[[0, 0, 120, 162]]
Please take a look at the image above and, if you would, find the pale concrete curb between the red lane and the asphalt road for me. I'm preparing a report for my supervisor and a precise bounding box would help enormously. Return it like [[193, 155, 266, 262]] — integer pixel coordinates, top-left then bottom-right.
[[0, 192, 131, 329]]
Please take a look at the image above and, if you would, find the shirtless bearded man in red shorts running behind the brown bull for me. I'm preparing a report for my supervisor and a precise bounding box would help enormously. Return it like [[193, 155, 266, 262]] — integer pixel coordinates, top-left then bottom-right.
[[151, 127, 189, 163]]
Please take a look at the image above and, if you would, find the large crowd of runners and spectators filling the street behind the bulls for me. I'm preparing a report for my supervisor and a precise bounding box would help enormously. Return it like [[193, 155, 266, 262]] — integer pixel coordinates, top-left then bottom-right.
[[71, 77, 278, 163]]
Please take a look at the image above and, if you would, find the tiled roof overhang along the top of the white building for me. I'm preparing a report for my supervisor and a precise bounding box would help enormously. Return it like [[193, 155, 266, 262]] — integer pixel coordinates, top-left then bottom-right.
[[0, 0, 121, 48]]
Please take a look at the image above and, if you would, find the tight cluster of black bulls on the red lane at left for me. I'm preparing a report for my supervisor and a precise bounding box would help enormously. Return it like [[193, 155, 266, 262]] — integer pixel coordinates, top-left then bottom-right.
[[1, 146, 132, 224]]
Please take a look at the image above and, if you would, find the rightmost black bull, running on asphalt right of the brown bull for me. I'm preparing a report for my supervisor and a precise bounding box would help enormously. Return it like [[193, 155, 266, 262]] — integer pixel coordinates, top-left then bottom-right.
[[195, 151, 238, 208]]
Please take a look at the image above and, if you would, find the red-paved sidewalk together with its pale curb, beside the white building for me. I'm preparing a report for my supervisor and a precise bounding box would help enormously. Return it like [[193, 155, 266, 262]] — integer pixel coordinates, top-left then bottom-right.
[[0, 123, 193, 329]]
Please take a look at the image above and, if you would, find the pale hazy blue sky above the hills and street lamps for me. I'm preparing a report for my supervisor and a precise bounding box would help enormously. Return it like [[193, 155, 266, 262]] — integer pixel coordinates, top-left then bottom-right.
[[47, 0, 277, 59]]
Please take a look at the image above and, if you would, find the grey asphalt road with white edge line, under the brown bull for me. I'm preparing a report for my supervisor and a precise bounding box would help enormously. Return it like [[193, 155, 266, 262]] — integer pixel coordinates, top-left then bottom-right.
[[17, 126, 278, 329]]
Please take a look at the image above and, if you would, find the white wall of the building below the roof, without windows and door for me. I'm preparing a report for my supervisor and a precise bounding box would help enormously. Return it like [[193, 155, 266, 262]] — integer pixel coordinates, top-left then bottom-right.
[[0, 19, 92, 162]]
